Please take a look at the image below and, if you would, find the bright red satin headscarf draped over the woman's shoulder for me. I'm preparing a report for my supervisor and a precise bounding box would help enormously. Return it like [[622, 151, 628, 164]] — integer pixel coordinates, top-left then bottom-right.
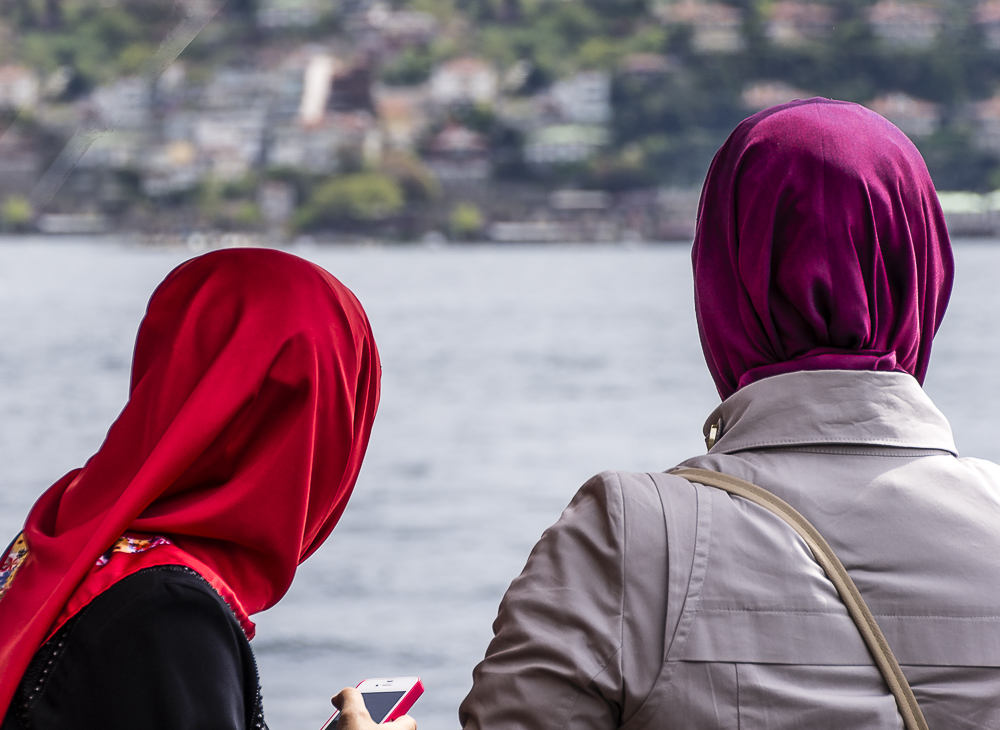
[[0, 249, 380, 718]]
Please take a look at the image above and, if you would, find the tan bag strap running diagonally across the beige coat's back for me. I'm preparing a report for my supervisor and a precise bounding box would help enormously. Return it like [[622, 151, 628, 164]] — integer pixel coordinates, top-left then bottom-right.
[[670, 469, 928, 730]]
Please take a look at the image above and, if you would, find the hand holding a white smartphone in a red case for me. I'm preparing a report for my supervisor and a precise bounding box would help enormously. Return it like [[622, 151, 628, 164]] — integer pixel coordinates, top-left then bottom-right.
[[322, 677, 424, 730]]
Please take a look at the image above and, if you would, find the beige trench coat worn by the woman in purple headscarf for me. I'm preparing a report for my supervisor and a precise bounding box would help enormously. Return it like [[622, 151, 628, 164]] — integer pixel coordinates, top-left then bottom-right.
[[460, 370, 1000, 730]]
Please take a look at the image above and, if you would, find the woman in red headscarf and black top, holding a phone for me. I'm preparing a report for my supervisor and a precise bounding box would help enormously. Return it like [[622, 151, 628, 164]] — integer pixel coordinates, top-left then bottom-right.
[[0, 249, 380, 730]]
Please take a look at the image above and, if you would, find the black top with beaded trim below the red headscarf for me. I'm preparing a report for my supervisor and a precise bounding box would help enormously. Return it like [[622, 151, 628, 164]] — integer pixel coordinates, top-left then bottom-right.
[[0, 565, 267, 730]]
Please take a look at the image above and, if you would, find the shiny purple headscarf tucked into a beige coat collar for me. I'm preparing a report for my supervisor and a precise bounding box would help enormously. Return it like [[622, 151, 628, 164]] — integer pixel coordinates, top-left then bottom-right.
[[692, 99, 954, 398]]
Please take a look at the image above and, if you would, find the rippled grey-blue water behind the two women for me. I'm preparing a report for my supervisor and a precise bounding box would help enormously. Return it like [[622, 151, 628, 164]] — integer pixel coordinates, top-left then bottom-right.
[[0, 239, 1000, 730]]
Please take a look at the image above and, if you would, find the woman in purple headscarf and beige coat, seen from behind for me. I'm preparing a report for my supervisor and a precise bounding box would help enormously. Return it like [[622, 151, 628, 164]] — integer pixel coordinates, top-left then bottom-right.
[[459, 99, 1000, 730]]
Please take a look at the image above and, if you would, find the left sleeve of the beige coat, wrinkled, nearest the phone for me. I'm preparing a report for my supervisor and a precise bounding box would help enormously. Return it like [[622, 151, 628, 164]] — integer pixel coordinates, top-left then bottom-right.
[[459, 472, 625, 730]]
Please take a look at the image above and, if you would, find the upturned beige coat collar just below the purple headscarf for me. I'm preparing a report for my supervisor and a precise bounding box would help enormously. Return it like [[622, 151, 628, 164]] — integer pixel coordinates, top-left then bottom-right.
[[704, 370, 958, 456]]
